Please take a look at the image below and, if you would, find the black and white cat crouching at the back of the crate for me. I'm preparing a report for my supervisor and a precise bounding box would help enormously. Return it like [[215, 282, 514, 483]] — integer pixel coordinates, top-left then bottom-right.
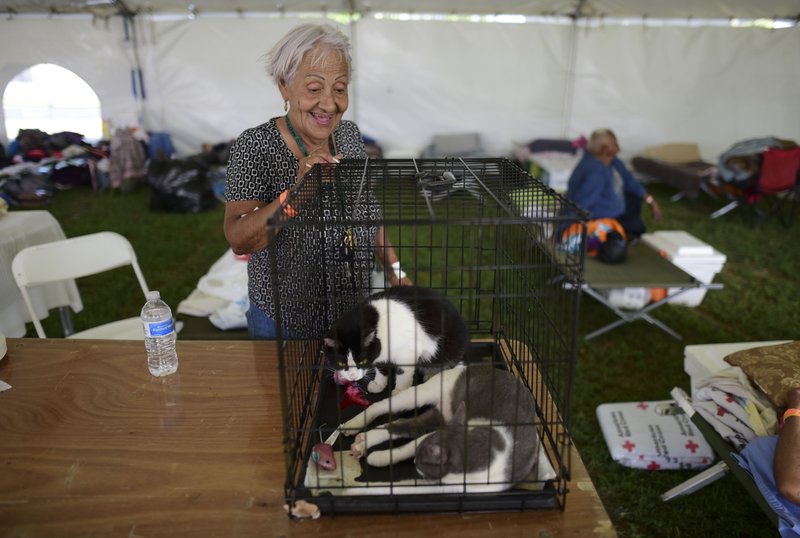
[[322, 286, 469, 393]]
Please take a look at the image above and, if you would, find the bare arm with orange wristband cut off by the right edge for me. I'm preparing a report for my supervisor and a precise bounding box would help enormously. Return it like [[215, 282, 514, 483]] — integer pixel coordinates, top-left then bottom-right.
[[772, 388, 800, 505]]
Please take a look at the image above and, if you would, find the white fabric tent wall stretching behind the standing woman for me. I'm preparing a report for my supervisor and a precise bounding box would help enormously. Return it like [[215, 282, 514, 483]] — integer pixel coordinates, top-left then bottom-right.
[[0, 12, 800, 160]]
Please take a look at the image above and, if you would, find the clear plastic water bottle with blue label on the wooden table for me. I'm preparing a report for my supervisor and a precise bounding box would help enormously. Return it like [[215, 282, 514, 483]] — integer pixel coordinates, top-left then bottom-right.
[[141, 291, 178, 377]]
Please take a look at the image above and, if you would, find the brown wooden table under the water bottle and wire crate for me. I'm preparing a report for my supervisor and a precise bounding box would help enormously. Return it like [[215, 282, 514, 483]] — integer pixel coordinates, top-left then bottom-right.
[[0, 339, 615, 538]]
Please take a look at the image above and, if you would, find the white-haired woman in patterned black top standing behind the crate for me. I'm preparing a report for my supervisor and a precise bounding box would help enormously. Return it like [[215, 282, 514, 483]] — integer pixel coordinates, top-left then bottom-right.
[[224, 24, 411, 339]]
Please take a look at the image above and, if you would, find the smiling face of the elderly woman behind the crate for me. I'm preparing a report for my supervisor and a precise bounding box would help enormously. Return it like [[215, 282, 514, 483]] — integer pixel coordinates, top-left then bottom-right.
[[280, 46, 350, 151]]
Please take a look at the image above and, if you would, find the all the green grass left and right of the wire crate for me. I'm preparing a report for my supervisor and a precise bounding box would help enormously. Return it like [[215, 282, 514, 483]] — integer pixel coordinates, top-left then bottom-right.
[[14, 178, 800, 537]]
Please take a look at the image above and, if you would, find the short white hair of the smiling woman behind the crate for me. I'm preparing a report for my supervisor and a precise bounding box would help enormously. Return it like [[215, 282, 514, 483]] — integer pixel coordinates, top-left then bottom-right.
[[267, 23, 351, 84]]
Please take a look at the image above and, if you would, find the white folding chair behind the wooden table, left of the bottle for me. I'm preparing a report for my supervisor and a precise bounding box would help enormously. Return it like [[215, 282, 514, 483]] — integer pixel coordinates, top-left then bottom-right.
[[11, 232, 149, 340]]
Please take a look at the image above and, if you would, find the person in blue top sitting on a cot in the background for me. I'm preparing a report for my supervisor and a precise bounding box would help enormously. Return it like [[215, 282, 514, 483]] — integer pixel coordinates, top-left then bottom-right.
[[566, 129, 661, 240]]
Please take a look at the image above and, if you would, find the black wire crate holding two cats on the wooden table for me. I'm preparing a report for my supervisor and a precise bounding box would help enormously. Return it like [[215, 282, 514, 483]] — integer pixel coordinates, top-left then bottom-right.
[[268, 159, 583, 514]]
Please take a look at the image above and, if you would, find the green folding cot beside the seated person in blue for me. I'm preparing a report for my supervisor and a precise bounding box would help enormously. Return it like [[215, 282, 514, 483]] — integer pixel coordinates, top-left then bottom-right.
[[582, 242, 722, 340]]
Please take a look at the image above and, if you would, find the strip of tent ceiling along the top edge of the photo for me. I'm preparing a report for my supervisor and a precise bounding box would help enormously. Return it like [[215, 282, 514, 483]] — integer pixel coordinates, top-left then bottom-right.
[[0, 0, 800, 19]]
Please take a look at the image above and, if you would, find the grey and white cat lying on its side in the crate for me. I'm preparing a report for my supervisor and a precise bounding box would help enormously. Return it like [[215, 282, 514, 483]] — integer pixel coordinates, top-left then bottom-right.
[[339, 365, 539, 495]]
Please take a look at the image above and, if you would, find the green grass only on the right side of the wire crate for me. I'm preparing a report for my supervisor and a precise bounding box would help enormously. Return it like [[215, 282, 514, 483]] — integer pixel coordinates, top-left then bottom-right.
[[567, 181, 800, 537]]
